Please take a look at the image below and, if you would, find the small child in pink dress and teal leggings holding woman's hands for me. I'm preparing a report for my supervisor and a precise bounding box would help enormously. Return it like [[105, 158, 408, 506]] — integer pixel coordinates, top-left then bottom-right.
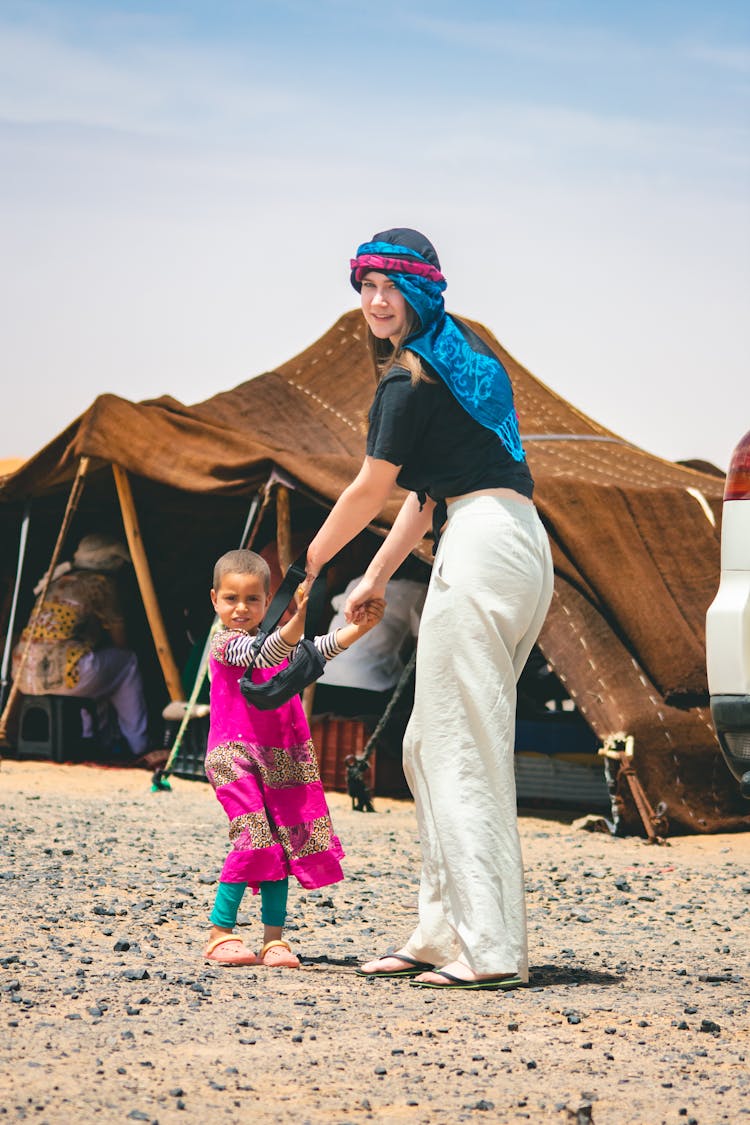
[[204, 550, 385, 969]]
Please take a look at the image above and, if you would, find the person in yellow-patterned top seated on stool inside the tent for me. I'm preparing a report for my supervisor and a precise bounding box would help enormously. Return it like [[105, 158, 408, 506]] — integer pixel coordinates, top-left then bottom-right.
[[13, 532, 165, 768]]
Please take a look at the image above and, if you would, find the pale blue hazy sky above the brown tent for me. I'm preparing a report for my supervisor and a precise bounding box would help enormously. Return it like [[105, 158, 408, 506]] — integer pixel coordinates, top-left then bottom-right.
[[0, 0, 750, 469]]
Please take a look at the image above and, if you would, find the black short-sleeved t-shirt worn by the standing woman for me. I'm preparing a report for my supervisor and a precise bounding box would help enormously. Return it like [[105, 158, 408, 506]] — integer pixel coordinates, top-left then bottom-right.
[[367, 367, 534, 501]]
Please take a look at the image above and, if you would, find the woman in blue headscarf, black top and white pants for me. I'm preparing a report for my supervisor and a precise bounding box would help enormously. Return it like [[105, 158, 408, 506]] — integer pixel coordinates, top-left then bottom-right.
[[307, 228, 552, 989]]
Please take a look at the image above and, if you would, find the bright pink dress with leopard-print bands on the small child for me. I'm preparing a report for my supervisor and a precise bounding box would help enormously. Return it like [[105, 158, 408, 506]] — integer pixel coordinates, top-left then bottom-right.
[[206, 628, 344, 891]]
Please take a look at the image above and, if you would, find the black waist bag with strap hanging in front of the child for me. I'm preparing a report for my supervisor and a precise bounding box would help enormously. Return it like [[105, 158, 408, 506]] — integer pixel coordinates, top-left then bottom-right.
[[240, 555, 326, 711]]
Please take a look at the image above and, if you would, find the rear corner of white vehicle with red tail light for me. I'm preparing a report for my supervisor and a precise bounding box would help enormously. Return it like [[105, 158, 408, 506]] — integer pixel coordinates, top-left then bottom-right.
[[706, 433, 750, 799]]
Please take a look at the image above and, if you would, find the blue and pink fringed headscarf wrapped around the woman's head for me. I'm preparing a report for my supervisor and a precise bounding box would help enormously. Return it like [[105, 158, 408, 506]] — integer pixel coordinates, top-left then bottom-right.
[[351, 227, 525, 461]]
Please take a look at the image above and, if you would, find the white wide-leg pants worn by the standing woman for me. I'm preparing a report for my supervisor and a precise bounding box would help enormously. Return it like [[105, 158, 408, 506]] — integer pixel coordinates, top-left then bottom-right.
[[404, 496, 553, 980]]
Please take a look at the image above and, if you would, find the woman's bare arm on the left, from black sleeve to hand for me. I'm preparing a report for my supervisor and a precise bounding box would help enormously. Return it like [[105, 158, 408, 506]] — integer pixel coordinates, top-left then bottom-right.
[[307, 457, 408, 585]]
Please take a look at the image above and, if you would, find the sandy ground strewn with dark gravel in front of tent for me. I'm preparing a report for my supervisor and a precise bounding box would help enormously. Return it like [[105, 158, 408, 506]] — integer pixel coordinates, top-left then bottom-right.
[[0, 761, 750, 1125]]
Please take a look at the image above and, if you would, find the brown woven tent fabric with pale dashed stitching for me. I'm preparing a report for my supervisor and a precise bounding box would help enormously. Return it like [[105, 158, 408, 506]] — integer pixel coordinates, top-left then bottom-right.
[[0, 311, 750, 831]]
